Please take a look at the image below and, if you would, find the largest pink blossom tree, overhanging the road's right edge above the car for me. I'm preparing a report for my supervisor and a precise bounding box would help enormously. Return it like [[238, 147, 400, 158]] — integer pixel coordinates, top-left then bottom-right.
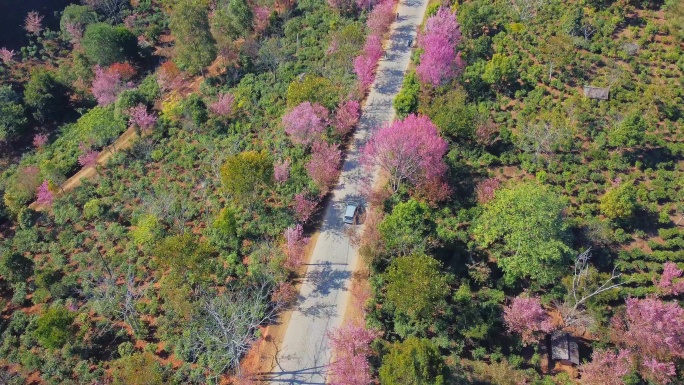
[[362, 114, 447, 192]]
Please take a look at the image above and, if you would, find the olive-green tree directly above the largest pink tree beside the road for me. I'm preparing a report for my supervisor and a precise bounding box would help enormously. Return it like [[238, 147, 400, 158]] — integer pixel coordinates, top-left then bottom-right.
[[424, 88, 477, 139]]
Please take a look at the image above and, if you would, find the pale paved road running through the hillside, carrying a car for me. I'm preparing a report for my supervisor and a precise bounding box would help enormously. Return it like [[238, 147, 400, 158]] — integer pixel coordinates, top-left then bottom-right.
[[269, 0, 428, 385]]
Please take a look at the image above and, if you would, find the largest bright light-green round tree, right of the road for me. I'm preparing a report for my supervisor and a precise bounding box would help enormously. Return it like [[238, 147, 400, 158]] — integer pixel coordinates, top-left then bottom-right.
[[472, 183, 571, 285]]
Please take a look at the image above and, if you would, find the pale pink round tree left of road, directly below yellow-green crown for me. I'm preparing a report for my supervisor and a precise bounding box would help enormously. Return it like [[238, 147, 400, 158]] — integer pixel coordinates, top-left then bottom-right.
[[283, 102, 328, 146]]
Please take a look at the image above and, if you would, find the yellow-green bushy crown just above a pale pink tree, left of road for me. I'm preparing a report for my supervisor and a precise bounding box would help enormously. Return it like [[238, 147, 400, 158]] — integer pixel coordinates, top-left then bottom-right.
[[287, 74, 340, 110]]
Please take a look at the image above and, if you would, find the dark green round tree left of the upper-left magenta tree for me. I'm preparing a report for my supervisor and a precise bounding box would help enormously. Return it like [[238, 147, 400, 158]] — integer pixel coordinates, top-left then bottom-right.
[[24, 68, 69, 122]]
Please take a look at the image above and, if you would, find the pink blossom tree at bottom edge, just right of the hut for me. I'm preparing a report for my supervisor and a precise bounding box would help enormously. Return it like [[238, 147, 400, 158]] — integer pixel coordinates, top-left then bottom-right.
[[579, 349, 634, 385]]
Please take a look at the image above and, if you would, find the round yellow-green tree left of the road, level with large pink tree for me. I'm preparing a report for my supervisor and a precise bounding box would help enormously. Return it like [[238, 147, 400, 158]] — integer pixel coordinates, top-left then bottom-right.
[[221, 151, 273, 207]]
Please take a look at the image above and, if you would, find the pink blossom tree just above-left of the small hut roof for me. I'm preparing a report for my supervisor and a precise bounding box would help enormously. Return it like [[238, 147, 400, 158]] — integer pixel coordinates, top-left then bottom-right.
[[504, 296, 553, 343]]
